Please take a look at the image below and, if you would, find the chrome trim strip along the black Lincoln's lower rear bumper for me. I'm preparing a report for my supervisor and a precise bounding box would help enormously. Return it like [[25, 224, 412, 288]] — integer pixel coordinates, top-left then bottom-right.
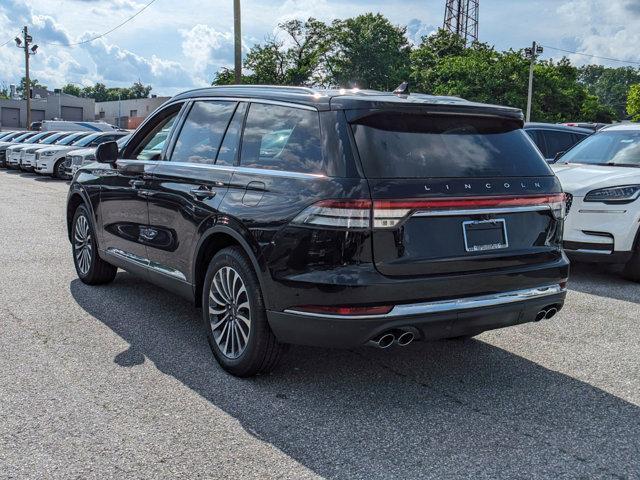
[[284, 284, 566, 320]]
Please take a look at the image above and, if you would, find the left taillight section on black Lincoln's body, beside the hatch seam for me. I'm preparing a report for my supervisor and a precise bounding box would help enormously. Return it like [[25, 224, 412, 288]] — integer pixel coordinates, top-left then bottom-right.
[[292, 200, 371, 229]]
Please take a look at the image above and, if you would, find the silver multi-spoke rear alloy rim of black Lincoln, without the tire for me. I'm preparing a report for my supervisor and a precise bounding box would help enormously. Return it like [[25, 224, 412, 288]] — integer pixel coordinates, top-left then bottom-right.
[[209, 266, 251, 359]]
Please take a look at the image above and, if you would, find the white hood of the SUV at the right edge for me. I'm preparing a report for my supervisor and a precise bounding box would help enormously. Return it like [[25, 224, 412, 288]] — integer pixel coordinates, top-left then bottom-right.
[[551, 163, 640, 197]]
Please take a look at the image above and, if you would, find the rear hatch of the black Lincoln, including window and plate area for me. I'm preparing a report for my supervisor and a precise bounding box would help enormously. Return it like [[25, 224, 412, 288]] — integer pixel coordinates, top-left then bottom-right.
[[347, 110, 564, 276]]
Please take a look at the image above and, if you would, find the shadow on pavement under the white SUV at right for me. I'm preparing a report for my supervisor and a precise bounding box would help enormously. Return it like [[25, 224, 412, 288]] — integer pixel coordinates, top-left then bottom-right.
[[569, 261, 640, 303]]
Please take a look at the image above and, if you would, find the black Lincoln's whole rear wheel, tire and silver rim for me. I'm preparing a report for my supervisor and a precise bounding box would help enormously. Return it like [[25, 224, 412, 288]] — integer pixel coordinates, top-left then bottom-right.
[[202, 247, 285, 377]]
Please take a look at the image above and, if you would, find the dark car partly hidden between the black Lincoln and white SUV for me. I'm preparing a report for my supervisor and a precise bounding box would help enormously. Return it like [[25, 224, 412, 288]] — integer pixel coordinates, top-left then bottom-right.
[[524, 122, 593, 163]]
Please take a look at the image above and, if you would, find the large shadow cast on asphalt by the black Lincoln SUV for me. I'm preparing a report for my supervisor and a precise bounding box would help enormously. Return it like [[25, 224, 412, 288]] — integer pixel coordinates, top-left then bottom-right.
[[70, 273, 640, 479]]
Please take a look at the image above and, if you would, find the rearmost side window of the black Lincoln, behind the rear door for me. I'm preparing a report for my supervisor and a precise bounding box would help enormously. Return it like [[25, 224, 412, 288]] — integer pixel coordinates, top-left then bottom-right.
[[241, 103, 323, 173]]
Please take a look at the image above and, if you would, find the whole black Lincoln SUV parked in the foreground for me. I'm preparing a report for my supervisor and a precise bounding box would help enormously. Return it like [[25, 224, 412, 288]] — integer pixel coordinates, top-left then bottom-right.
[[67, 86, 569, 376]]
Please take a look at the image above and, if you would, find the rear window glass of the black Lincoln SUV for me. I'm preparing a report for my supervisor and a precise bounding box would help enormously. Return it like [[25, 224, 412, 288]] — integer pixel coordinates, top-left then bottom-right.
[[351, 112, 552, 178]]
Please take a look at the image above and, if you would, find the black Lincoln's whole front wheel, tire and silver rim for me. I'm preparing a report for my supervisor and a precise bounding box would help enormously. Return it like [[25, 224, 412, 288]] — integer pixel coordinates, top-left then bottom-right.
[[71, 205, 118, 285]]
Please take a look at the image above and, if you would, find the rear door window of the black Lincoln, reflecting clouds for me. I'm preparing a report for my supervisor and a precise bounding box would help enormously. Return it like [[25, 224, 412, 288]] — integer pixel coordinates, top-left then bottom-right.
[[171, 101, 236, 163]]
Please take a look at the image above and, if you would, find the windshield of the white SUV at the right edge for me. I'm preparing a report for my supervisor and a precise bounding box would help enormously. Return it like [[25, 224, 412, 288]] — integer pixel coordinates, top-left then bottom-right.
[[560, 130, 640, 167]]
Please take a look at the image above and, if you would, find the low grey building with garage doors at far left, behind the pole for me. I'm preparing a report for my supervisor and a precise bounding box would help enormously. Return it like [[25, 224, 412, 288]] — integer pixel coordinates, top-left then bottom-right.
[[0, 89, 95, 129]]
